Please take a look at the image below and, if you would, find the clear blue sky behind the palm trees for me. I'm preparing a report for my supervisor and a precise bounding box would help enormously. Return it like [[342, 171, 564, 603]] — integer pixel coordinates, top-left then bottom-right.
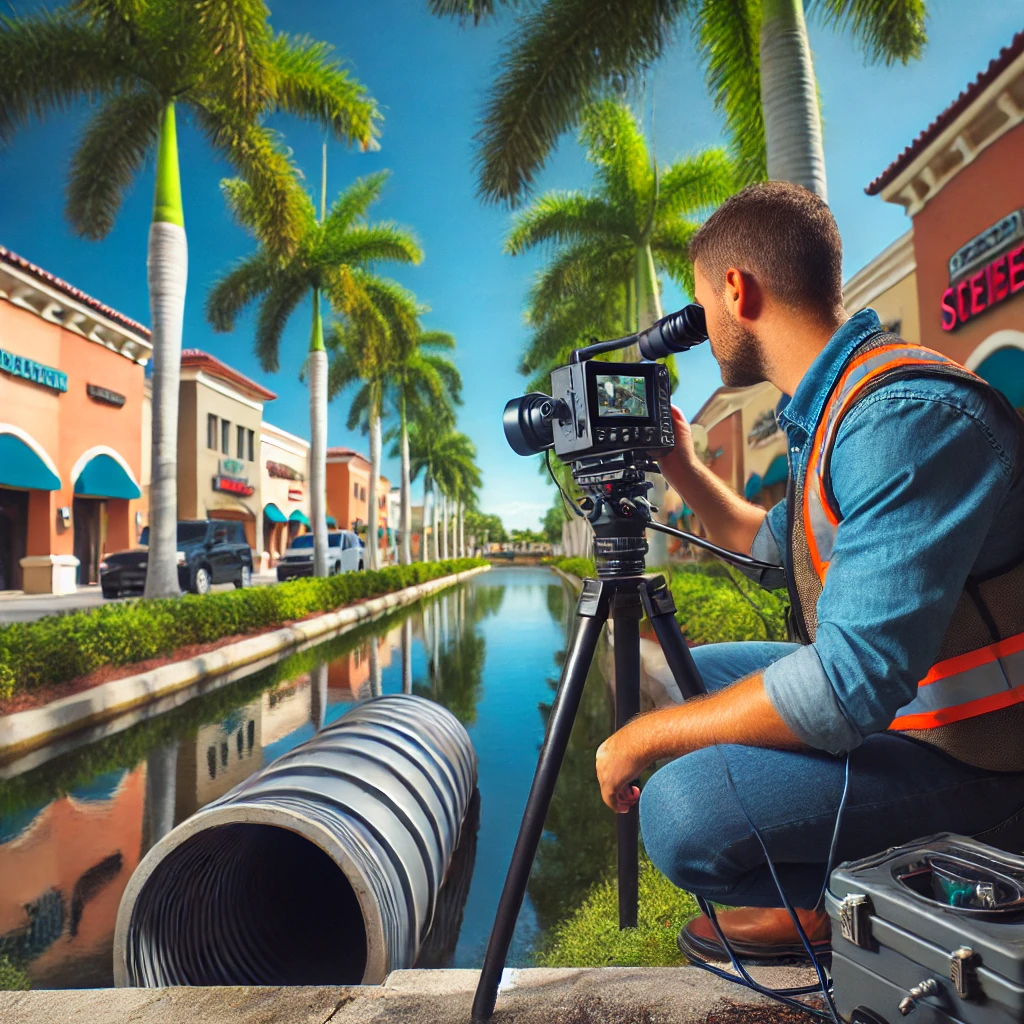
[[0, 0, 1024, 526]]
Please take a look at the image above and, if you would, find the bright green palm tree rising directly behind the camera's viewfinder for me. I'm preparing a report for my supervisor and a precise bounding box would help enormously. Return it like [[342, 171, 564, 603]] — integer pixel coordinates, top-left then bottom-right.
[[505, 99, 735, 333]]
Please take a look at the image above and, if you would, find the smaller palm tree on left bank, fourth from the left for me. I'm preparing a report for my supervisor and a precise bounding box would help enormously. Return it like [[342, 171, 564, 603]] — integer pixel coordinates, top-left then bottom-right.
[[388, 324, 462, 565]]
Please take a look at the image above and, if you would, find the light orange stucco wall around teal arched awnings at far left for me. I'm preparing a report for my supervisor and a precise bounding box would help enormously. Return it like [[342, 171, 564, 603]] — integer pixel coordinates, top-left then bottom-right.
[[0, 300, 144, 555]]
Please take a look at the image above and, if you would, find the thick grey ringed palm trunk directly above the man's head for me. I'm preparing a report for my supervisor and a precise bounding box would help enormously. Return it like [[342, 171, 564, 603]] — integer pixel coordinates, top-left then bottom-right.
[[761, 0, 828, 202]]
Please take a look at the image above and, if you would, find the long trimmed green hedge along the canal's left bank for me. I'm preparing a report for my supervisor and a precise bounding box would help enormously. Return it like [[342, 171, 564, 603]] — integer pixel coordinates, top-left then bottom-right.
[[0, 558, 486, 697]]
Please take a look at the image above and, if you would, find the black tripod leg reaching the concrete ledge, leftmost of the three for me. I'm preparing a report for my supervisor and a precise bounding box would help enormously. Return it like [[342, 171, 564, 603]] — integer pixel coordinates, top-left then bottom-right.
[[473, 580, 608, 1021]]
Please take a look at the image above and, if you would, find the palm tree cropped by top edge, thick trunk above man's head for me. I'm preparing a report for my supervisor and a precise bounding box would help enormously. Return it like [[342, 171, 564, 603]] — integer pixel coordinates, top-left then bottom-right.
[[428, 0, 927, 204]]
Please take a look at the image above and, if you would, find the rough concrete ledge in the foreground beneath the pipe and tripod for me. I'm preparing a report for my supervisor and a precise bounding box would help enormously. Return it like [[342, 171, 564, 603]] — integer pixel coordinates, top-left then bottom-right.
[[0, 967, 808, 1024]]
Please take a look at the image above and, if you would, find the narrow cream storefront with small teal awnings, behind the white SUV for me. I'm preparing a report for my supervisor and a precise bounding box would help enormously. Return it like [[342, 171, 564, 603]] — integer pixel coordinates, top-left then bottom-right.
[[260, 421, 310, 571]]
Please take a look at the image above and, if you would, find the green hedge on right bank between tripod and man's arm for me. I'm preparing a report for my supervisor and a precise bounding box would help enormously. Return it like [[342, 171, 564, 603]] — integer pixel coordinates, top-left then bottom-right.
[[547, 558, 788, 644]]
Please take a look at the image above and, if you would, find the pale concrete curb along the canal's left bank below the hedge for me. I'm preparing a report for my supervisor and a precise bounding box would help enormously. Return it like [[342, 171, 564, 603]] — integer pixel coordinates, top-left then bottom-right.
[[0, 565, 490, 761]]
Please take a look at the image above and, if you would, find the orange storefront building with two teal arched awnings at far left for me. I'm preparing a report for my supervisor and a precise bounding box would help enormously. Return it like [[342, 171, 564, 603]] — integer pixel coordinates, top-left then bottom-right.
[[0, 246, 153, 594]]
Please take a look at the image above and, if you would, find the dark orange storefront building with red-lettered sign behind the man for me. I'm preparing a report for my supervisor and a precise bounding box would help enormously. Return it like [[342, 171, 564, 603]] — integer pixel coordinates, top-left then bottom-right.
[[861, 32, 1024, 409]]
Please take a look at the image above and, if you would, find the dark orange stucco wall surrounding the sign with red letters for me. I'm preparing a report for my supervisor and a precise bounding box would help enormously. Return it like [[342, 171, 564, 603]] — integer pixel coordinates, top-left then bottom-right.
[[913, 124, 1024, 362]]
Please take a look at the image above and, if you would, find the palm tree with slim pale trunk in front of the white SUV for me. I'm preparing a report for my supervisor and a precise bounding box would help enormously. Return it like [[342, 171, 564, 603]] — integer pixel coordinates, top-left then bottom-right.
[[206, 171, 422, 575]]
